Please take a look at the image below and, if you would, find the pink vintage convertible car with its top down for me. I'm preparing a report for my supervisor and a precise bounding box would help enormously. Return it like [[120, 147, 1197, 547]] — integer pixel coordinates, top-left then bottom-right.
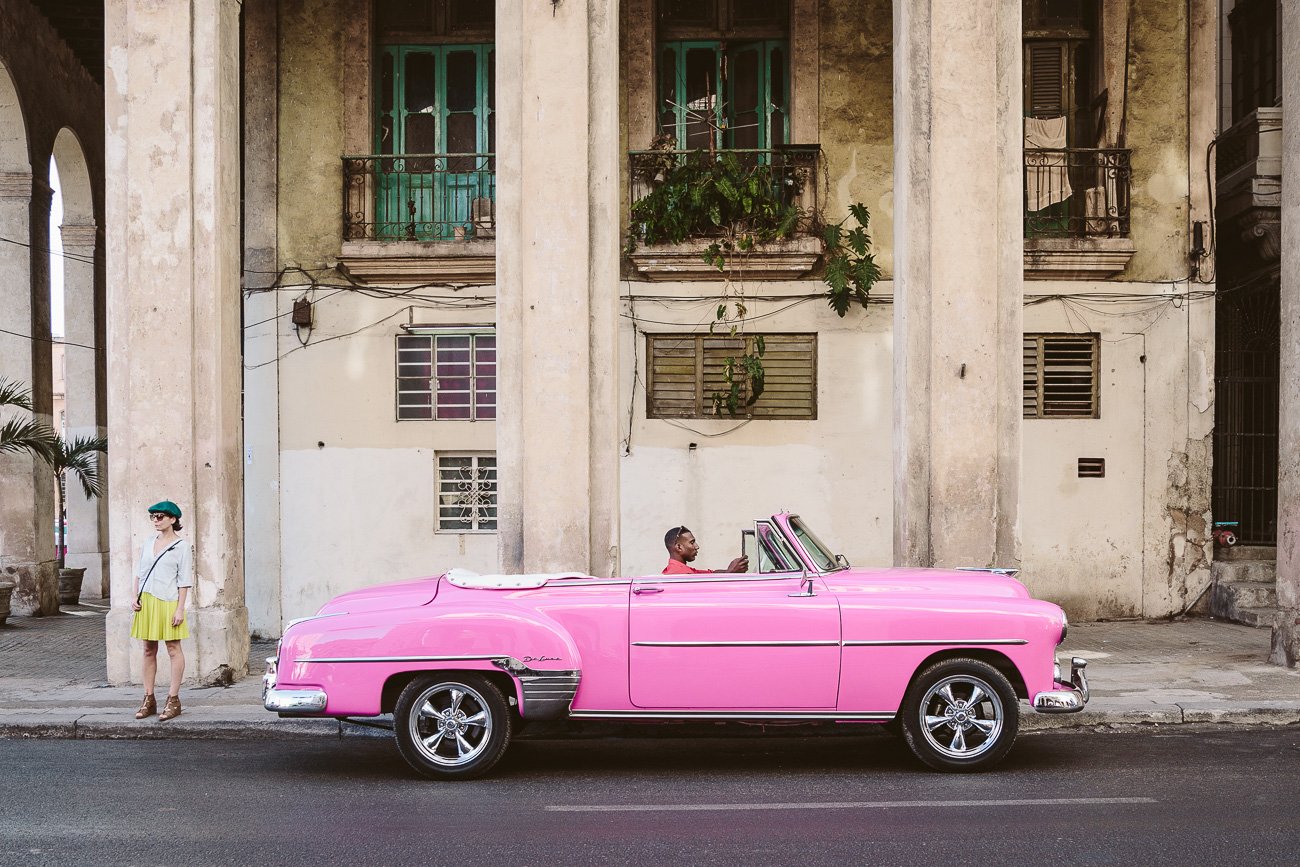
[[263, 512, 1088, 779]]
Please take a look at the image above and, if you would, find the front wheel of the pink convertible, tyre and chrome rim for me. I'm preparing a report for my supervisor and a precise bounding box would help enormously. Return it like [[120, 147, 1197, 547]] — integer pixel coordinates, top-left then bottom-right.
[[902, 659, 1021, 771]]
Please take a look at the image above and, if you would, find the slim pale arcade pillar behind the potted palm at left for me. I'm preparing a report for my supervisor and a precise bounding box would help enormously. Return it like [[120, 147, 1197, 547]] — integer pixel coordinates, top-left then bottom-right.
[[60, 224, 108, 598]]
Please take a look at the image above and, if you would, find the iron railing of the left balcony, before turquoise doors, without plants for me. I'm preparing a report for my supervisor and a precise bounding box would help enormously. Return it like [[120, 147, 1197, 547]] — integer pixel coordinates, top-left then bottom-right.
[[343, 153, 497, 240]]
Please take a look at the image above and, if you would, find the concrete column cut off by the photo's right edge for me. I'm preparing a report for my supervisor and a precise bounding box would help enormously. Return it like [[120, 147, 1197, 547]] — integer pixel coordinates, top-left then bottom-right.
[[1270, 3, 1300, 667]]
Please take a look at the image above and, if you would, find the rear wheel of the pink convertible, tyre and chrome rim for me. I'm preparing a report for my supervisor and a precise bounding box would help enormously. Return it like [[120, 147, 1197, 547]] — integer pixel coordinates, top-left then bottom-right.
[[393, 673, 514, 780]]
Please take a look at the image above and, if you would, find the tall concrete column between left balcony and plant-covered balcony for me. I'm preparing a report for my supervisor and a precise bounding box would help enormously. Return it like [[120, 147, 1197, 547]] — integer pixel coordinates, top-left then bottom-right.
[[497, 0, 620, 575]]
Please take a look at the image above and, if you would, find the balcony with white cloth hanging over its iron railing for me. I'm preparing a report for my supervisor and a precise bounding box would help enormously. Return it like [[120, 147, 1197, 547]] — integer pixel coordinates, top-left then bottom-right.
[[1023, 148, 1134, 279]]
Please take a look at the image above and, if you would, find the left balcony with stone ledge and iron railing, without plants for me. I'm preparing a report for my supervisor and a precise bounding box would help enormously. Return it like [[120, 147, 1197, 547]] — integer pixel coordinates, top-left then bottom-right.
[[341, 153, 497, 283]]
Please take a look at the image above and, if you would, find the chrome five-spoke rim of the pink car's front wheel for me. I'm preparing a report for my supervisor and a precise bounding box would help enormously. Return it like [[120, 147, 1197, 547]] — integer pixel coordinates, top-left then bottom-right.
[[920, 675, 1005, 759]]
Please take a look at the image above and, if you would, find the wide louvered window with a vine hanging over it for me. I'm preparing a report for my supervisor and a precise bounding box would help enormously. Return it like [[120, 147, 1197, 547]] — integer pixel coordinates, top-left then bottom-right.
[[646, 334, 816, 420]]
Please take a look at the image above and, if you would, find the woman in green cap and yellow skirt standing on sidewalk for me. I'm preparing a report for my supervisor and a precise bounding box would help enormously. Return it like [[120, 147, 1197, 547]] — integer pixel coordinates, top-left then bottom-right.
[[131, 499, 194, 723]]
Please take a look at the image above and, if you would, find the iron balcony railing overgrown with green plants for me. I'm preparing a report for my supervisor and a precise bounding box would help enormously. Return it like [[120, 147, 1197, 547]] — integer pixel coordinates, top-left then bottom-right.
[[628, 144, 822, 237]]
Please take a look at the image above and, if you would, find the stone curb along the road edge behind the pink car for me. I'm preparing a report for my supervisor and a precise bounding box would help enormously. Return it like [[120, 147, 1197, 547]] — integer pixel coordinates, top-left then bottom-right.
[[0, 702, 1300, 741]]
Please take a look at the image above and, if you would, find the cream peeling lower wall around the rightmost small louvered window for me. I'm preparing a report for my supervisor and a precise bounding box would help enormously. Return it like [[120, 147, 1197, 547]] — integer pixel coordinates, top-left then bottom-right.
[[1021, 282, 1213, 620]]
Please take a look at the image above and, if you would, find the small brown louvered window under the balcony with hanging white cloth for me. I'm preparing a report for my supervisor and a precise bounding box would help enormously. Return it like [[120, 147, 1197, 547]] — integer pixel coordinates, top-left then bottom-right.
[[1024, 334, 1101, 419]]
